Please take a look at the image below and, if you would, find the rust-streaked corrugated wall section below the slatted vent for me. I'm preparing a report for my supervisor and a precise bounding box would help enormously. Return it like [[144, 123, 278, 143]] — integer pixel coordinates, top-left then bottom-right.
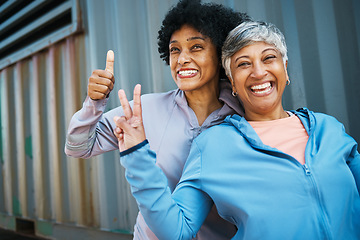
[[0, 34, 137, 239]]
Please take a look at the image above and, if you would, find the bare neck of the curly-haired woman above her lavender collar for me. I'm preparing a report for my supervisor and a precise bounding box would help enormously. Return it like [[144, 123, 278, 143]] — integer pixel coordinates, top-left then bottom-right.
[[185, 87, 222, 126]]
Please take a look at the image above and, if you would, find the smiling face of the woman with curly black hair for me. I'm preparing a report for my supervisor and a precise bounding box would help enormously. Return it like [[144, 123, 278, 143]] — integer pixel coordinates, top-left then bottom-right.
[[169, 25, 220, 93]]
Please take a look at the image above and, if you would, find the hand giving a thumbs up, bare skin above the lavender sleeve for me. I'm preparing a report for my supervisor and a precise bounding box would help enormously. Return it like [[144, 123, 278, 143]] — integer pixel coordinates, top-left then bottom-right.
[[88, 50, 115, 100]]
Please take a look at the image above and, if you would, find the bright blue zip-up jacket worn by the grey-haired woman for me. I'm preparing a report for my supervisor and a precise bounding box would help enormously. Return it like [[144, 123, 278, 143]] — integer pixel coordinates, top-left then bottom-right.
[[121, 109, 360, 240]]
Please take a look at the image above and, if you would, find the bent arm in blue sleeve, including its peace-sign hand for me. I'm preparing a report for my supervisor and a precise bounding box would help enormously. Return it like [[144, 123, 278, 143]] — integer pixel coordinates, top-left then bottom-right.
[[114, 85, 213, 239]]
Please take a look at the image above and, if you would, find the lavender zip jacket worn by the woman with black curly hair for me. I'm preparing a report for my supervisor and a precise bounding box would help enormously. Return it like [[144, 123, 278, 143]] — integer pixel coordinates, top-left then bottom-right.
[[65, 81, 243, 240]]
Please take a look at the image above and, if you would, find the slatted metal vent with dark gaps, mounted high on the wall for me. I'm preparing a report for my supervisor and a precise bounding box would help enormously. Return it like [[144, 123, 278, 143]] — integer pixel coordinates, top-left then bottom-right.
[[0, 0, 82, 69]]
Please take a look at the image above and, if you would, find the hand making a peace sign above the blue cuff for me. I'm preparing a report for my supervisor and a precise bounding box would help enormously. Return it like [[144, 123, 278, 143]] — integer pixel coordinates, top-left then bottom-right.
[[114, 84, 146, 152]]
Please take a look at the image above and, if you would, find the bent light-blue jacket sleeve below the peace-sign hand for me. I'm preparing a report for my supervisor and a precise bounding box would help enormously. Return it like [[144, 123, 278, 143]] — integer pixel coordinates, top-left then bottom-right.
[[120, 142, 213, 239]]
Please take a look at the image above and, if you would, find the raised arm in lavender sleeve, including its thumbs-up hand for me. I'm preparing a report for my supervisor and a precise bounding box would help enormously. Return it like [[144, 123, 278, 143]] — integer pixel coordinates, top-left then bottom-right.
[[65, 51, 122, 158]]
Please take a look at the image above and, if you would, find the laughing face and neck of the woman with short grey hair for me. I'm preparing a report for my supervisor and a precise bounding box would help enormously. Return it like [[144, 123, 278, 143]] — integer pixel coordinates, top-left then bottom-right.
[[230, 42, 289, 121]]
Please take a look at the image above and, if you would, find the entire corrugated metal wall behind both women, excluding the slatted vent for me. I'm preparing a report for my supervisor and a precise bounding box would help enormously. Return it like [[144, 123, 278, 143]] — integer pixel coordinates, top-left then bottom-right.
[[0, 0, 360, 239]]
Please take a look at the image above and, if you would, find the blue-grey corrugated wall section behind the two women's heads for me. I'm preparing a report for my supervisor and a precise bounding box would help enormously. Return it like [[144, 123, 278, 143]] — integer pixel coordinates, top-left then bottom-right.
[[85, 0, 360, 142]]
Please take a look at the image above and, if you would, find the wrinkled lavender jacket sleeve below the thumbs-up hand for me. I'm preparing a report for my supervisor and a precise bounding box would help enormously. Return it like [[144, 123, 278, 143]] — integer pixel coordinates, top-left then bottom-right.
[[65, 97, 122, 158]]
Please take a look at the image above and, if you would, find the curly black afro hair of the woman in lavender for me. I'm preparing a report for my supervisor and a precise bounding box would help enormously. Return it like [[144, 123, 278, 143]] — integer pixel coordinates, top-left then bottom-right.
[[158, 0, 251, 77]]
